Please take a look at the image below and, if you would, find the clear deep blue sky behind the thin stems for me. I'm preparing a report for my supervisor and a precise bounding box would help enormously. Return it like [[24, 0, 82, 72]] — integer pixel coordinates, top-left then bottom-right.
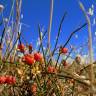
[[0, 0, 96, 60]]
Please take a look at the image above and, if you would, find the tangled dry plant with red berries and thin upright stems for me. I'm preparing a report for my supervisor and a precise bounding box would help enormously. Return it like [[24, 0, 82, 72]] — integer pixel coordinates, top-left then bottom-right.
[[0, 0, 96, 96]]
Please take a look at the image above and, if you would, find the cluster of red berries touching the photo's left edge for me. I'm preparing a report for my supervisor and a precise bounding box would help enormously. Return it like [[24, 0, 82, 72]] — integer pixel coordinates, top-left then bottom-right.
[[0, 76, 16, 84]]
